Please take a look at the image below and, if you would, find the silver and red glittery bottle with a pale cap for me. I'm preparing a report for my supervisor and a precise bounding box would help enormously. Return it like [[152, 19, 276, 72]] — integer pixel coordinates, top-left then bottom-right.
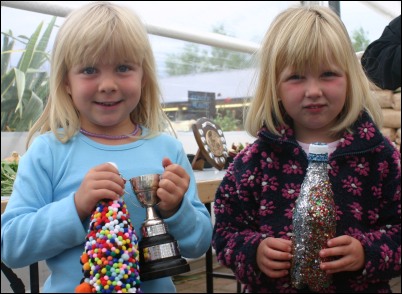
[[290, 143, 336, 292]]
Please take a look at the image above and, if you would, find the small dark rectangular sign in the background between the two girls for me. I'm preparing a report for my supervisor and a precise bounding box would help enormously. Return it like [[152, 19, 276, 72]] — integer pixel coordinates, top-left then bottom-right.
[[188, 91, 216, 118]]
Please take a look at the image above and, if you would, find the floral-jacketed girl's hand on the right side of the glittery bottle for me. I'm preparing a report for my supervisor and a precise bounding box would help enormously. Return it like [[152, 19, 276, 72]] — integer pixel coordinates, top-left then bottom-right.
[[320, 235, 364, 274]]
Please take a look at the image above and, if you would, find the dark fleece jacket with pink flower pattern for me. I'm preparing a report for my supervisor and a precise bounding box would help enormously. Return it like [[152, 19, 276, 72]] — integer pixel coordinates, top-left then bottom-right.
[[212, 114, 401, 293]]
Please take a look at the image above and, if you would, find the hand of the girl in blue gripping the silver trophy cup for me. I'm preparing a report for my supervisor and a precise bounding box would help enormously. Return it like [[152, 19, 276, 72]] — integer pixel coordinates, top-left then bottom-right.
[[156, 158, 190, 218]]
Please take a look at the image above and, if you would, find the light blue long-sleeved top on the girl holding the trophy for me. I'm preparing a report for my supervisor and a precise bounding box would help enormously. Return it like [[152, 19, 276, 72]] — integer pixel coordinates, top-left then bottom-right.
[[1, 129, 212, 293]]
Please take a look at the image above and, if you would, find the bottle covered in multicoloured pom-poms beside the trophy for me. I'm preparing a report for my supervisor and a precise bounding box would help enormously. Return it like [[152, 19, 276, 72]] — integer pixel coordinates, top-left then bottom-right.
[[75, 199, 141, 293]]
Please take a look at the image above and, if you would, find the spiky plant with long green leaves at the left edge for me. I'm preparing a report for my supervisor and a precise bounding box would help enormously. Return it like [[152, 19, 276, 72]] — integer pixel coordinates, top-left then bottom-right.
[[1, 17, 56, 132]]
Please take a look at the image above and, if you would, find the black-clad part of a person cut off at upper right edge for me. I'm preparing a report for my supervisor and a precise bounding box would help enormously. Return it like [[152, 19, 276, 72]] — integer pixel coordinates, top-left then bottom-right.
[[361, 15, 401, 90]]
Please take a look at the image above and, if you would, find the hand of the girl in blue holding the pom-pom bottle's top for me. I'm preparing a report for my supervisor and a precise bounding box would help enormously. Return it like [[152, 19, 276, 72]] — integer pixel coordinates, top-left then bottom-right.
[[74, 163, 125, 220]]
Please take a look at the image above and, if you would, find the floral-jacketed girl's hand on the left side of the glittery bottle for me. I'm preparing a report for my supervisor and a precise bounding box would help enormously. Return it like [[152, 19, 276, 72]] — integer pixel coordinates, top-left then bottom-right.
[[256, 237, 292, 278]]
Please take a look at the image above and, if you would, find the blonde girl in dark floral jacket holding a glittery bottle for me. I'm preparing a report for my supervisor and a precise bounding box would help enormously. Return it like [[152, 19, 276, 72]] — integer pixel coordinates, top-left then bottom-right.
[[213, 7, 401, 293]]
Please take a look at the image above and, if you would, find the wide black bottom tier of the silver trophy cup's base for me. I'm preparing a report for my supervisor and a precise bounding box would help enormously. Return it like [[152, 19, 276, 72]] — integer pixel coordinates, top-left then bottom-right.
[[140, 257, 190, 281]]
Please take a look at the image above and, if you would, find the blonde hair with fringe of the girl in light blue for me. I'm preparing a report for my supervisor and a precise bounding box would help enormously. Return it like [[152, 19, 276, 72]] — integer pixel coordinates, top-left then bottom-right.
[[27, 1, 174, 147]]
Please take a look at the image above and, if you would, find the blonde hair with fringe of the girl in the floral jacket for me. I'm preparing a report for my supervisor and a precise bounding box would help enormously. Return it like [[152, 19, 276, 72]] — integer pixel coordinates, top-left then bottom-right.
[[245, 6, 382, 137]]
